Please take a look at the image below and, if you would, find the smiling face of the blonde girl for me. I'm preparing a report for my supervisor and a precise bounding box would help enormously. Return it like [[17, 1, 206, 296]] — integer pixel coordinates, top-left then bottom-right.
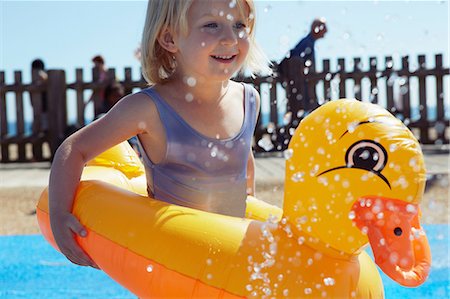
[[174, 0, 249, 81]]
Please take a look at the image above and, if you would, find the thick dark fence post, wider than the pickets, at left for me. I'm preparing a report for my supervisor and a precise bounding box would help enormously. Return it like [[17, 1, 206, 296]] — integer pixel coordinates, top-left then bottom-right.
[[48, 70, 67, 158]]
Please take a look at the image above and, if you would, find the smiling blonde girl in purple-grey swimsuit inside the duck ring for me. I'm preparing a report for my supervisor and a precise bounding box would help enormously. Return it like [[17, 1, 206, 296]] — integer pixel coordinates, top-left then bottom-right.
[[49, 0, 268, 267]]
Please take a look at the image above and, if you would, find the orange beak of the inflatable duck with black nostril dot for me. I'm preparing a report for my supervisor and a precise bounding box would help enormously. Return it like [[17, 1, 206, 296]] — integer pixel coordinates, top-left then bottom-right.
[[352, 196, 431, 287]]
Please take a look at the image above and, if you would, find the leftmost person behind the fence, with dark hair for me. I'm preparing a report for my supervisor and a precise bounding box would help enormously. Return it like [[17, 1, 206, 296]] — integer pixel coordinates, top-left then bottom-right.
[[31, 58, 48, 133]]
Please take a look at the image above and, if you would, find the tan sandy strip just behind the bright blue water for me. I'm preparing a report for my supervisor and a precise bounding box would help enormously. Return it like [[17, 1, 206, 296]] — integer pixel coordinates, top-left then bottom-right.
[[0, 175, 449, 235]]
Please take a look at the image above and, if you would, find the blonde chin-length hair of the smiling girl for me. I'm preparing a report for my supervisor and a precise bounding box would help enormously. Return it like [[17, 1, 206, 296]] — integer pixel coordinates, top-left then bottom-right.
[[141, 0, 271, 84]]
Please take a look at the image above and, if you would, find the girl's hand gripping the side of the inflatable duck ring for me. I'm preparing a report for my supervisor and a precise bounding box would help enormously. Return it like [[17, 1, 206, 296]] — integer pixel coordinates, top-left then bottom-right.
[[51, 213, 99, 269]]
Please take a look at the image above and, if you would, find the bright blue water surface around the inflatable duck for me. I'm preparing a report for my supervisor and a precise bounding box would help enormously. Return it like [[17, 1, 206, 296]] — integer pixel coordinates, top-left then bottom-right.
[[0, 225, 450, 299]]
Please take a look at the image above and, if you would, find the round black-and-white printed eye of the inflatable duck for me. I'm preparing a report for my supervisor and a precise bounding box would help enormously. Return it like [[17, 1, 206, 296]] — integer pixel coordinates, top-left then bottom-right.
[[345, 140, 387, 172]]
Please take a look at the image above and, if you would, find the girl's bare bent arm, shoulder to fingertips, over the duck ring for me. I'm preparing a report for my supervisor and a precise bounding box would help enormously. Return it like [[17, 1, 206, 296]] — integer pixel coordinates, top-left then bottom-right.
[[49, 94, 156, 267]]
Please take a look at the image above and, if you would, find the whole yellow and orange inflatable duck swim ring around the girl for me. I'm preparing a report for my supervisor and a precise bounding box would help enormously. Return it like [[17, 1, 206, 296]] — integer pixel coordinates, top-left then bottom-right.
[[37, 99, 431, 298]]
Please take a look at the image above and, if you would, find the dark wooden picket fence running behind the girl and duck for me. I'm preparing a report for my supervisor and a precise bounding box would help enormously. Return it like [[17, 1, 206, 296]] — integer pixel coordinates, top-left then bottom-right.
[[0, 55, 450, 163]]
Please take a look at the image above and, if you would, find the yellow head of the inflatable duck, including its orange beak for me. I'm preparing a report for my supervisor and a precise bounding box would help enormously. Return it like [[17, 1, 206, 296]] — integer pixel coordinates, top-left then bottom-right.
[[283, 99, 431, 286]]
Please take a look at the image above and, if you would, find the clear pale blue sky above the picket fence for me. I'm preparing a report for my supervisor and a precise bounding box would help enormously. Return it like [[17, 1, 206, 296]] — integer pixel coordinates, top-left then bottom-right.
[[0, 0, 450, 122]]
